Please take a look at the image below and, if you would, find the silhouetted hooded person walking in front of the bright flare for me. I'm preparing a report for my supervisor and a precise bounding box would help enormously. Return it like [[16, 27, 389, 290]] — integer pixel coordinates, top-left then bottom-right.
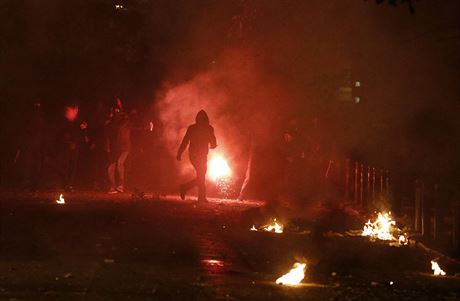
[[177, 110, 217, 202]]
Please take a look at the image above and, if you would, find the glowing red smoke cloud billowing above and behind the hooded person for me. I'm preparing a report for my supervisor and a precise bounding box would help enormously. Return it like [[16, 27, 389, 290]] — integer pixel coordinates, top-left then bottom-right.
[[155, 49, 283, 183]]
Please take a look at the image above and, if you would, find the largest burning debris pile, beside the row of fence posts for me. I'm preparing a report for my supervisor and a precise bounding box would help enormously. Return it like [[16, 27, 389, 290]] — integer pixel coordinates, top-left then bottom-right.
[[361, 212, 409, 245]]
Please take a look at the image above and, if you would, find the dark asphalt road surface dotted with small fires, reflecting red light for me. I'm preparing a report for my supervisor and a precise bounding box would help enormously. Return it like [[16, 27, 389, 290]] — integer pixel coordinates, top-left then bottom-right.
[[0, 193, 460, 300]]
